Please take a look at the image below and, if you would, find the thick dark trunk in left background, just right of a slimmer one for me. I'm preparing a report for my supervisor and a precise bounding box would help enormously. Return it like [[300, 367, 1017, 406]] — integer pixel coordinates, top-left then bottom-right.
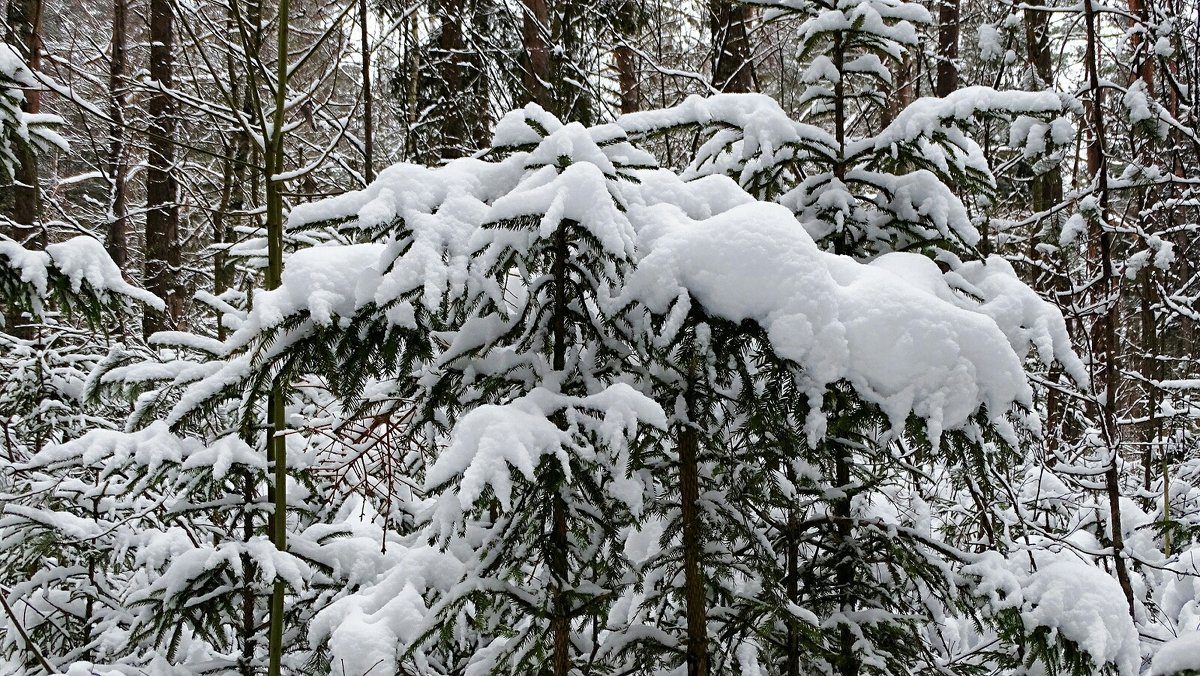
[[143, 0, 184, 335]]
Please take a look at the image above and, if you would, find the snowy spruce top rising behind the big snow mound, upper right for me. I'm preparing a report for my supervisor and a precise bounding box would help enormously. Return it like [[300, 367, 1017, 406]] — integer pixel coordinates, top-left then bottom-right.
[[618, 0, 1074, 257]]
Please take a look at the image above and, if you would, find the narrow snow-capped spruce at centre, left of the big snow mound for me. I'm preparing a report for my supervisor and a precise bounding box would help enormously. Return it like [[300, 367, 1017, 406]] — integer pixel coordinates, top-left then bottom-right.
[[415, 106, 664, 676]]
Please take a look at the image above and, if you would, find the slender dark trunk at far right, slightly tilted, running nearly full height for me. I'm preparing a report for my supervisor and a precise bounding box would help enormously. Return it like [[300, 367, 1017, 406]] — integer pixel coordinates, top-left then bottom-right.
[[1084, 0, 1135, 617]]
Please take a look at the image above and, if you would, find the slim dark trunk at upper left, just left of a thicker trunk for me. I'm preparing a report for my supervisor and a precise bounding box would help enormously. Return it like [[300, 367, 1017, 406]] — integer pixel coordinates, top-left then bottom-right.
[[106, 0, 130, 273]]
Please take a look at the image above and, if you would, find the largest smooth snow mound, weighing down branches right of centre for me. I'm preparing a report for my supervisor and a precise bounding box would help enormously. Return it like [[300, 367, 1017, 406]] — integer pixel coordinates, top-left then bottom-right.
[[625, 203, 1032, 441]]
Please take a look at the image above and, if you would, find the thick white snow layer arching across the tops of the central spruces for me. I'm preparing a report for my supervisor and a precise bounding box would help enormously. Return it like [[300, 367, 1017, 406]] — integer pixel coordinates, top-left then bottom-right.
[[226, 102, 1086, 449]]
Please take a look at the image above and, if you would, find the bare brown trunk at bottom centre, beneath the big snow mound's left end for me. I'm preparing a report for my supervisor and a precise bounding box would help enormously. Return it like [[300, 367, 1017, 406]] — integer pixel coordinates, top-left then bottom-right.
[[678, 417, 709, 676]]
